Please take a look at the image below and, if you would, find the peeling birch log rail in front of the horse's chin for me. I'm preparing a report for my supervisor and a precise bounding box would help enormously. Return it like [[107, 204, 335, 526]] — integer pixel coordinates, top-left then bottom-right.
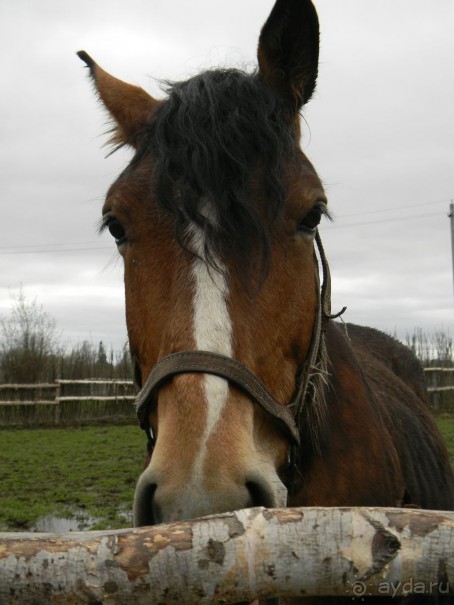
[[0, 508, 454, 605]]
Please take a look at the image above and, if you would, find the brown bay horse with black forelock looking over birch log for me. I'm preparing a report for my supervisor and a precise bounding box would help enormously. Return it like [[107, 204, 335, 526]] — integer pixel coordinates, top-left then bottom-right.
[[78, 0, 454, 604]]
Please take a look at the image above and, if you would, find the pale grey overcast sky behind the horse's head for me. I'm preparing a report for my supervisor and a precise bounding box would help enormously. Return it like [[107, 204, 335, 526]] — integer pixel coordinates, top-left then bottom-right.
[[0, 0, 454, 348]]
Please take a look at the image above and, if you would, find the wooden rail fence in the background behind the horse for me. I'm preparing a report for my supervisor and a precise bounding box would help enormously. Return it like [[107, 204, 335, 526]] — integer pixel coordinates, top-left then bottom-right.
[[0, 367, 454, 427]]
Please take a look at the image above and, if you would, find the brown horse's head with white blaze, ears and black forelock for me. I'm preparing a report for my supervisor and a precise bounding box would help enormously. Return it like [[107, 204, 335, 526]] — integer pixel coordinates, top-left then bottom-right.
[[79, 0, 327, 525]]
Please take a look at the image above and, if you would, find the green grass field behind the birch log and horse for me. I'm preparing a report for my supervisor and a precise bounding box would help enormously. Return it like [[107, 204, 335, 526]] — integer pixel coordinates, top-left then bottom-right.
[[0, 414, 454, 531]]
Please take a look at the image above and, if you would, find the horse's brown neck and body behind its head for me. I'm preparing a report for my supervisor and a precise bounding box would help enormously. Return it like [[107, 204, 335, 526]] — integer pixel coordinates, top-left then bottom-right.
[[290, 324, 454, 510]]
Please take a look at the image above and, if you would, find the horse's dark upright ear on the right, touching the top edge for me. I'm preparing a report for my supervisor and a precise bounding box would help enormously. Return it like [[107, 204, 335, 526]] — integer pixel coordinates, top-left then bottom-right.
[[258, 0, 319, 112]]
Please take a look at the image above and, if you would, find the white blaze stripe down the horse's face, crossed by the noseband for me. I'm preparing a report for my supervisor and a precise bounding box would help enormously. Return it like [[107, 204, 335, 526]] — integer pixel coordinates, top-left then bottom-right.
[[192, 224, 232, 481]]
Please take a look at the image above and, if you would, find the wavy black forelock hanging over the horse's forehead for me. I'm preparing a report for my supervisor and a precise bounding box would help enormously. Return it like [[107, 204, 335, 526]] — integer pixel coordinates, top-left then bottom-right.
[[139, 70, 296, 272]]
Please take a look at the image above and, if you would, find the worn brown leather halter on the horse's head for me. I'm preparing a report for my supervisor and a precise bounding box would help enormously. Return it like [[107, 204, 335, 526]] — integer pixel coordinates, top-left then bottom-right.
[[136, 232, 345, 486]]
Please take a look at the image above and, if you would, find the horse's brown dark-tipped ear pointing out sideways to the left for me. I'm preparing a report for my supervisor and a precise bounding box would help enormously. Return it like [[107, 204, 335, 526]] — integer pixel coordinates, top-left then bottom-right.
[[77, 50, 158, 147]]
